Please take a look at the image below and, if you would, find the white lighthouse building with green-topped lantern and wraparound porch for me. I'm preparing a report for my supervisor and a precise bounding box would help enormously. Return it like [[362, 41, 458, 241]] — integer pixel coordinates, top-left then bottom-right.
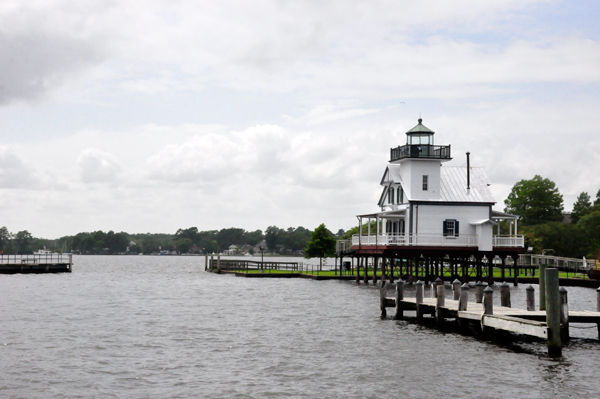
[[338, 119, 524, 284]]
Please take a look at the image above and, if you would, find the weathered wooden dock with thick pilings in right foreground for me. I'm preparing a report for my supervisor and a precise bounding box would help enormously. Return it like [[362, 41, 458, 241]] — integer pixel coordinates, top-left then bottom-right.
[[380, 269, 600, 356]]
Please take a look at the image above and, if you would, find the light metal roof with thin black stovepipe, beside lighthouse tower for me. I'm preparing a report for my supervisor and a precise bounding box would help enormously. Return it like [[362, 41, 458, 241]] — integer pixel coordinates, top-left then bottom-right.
[[440, 166, 496, 203]]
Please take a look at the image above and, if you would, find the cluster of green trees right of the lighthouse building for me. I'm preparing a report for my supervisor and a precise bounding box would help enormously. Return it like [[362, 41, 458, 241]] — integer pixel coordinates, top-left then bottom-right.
[[502, 175, 600, 258]]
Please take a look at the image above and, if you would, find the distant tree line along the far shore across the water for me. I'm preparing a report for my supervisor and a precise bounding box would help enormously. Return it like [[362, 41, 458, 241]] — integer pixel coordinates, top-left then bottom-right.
[[0, 226, 344, 255]]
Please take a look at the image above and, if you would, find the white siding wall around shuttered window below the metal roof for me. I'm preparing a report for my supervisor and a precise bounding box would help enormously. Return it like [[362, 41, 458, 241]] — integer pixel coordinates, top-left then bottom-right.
[[413, 205, 491, 236]]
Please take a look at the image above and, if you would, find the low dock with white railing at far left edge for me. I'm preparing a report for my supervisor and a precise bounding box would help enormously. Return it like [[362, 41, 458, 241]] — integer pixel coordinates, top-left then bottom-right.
[[0, 254, 73, 274]]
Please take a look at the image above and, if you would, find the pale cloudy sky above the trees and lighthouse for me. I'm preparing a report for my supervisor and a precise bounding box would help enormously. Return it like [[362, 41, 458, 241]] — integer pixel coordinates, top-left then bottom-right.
[[0, 0, 600, 238]]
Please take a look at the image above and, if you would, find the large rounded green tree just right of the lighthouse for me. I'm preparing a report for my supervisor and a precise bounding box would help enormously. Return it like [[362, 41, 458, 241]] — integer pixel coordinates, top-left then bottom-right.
[[504, 175, 563, 226]]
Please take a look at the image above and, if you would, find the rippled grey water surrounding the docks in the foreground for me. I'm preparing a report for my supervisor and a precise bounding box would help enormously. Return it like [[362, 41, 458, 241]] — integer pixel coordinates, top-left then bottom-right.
[[0, 256, 600, 398]]
